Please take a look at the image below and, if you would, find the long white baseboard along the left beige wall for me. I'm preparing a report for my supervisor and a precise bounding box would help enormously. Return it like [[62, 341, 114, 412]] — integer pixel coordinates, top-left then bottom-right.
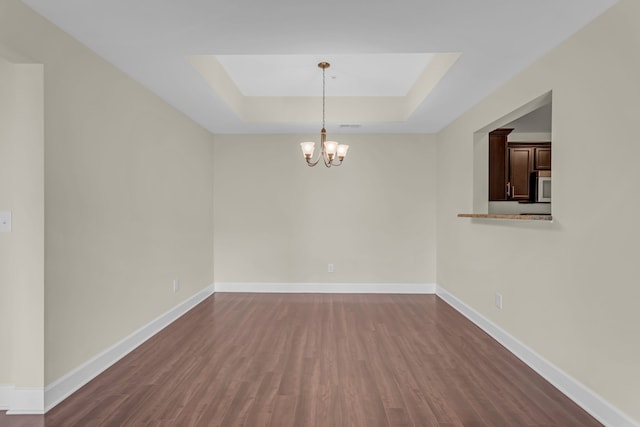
[[44, 285, 214, 411]]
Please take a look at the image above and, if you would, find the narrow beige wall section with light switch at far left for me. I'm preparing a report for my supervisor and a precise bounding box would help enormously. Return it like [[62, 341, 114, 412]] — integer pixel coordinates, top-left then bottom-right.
[[0, 57, 44, 388]]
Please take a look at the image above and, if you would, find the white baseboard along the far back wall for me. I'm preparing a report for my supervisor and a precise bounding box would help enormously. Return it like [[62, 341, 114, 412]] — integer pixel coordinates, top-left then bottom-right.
[[215, 282, 436, 294]]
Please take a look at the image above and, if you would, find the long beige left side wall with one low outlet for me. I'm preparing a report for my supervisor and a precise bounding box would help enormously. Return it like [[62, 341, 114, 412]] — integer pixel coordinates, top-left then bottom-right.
[[0, 0, 213, 384]]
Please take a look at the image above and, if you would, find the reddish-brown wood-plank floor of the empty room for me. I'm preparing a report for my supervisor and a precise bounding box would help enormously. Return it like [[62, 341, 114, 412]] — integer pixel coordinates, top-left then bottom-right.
[[13, 293, 600, 427]]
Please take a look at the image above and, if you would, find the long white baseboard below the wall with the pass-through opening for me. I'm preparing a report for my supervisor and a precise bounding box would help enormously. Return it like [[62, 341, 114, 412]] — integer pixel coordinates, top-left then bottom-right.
[[436, 286, 640, 427]]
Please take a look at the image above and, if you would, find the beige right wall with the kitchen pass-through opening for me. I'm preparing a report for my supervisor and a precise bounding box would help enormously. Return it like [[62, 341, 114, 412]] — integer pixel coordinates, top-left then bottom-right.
[[437, 0, 640, 421]]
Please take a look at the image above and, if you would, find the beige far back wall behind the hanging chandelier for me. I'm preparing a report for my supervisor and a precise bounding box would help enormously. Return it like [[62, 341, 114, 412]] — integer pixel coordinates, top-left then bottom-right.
[[214, 135, 435, 283]]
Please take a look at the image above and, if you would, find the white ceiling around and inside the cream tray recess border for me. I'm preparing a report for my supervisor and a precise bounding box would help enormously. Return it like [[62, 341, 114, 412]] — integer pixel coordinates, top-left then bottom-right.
[[23, 0, 617, 133]]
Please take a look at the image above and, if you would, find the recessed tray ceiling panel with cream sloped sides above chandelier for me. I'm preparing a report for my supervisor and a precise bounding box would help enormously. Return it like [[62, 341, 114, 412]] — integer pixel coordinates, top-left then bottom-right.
[[188, 52, 460, 123]]
